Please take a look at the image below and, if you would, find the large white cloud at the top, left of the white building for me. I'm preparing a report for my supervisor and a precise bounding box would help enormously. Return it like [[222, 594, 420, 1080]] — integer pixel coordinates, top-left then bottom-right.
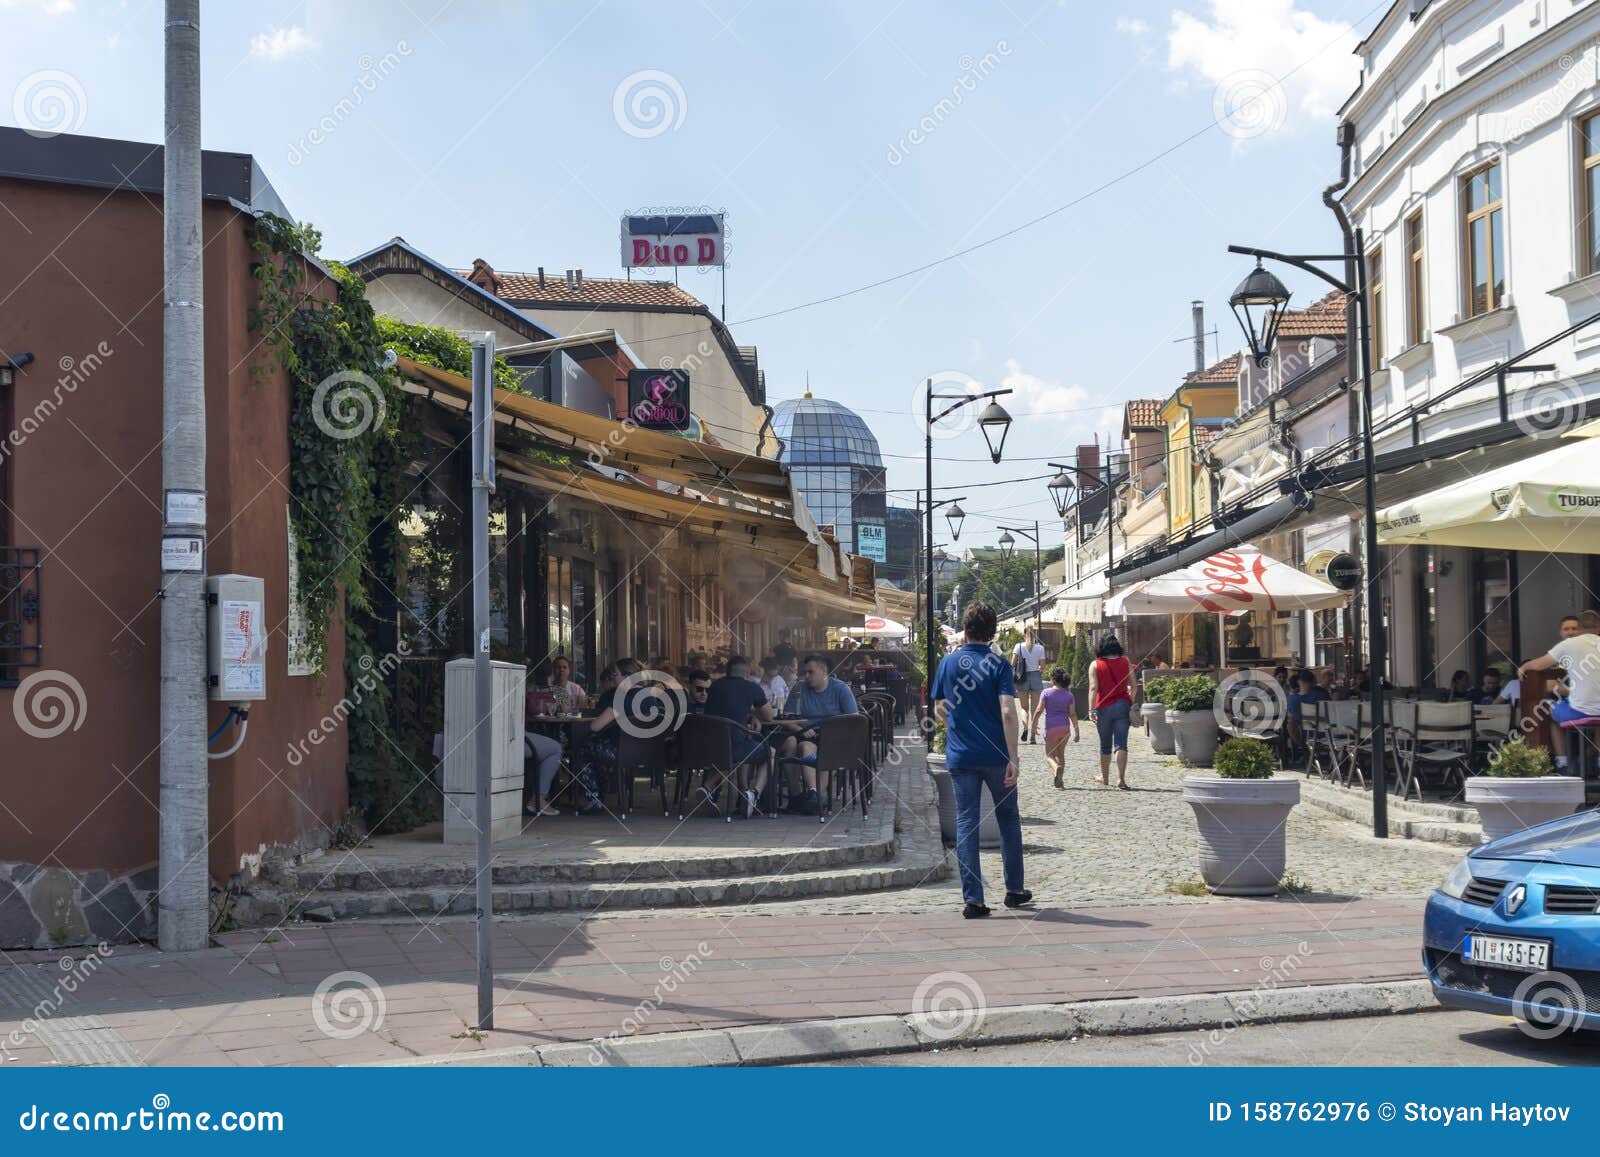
[[1166, 0, 1360, 138]]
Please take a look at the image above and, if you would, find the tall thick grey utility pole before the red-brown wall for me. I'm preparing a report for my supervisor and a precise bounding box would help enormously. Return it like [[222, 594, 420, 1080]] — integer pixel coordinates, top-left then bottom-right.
[[157, 0, 211, 952]]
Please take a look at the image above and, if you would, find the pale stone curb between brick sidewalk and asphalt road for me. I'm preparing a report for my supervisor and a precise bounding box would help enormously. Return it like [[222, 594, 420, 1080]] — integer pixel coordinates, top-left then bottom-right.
[[368, 979, 1440, 1067]]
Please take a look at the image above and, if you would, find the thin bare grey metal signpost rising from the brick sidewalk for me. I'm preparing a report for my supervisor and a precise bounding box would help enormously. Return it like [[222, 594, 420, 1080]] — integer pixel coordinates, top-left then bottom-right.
[[470, 331, 494, 1031]]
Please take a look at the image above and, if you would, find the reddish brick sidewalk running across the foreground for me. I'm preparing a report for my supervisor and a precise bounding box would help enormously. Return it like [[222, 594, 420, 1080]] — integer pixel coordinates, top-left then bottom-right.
[[0, 898, 1421, 1064]]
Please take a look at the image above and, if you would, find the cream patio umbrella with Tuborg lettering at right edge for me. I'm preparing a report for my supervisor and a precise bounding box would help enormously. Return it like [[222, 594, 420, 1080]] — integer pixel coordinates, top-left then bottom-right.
[[1378, 438, 1600, 554]]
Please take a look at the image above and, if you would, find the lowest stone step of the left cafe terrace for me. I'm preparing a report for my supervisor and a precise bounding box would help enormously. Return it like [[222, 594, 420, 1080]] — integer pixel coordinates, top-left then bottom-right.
[[234, 848, 950, 928]]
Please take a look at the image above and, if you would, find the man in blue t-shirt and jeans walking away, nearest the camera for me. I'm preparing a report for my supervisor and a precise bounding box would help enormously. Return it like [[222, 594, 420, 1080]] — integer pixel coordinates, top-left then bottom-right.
[[930, 603, 1034, 920]]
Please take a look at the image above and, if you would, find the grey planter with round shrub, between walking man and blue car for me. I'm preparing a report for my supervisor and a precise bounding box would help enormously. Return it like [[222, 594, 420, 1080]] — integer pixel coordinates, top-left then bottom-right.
[[1181, 742, 1299, 896]]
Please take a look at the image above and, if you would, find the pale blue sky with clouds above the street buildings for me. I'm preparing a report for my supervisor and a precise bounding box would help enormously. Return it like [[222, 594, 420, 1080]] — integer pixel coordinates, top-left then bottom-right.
[[0, 0, 1387, 546]]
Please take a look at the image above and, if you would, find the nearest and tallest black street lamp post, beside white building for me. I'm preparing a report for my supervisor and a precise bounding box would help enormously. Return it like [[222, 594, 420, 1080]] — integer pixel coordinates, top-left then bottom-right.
[[1227, 229, 1389, 840]]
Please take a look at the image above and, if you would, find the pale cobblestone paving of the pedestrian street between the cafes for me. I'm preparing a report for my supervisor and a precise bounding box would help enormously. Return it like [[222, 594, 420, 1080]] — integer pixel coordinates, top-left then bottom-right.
[[694, 727, 1466, 912]]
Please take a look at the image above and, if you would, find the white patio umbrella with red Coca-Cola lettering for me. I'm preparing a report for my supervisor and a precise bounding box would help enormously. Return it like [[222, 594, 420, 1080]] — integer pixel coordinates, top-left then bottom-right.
[[1106, 546, 1350, 666]]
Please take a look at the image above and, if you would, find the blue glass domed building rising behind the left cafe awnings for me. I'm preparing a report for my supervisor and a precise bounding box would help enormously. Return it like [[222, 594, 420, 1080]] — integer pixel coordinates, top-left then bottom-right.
[[773, 394, 886, 562]]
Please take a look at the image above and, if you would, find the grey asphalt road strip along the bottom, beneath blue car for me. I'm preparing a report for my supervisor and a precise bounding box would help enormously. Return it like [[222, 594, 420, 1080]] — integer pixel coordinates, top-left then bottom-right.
[[825, 1011, 1600, 1067]]
